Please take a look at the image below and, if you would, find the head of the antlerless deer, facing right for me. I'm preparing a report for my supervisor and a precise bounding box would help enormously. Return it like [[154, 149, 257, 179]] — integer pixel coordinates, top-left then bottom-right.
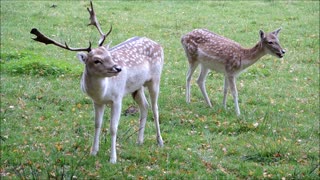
[[259, 28, 286, 58]]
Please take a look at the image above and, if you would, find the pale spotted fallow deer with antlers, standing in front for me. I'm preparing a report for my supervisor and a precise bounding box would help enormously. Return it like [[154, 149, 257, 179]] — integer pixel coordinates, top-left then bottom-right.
[[31, 2, 164, 163]]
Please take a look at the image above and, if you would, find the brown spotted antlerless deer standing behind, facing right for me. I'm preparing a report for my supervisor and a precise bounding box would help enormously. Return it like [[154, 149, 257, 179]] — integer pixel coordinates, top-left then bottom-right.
[[181, 28, 285, 116]]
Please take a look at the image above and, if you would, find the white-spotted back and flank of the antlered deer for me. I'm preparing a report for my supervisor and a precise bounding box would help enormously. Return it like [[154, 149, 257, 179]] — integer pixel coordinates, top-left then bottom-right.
[[110, 37, 164, 93]]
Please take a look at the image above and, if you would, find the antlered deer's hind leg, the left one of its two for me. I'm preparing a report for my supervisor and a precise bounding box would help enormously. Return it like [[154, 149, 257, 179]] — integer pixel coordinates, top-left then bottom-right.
[[132, 87, 148, 144]]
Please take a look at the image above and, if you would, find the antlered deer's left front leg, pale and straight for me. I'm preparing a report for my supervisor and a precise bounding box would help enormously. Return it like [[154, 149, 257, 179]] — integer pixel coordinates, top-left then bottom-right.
[[90, 103, 105, 155]]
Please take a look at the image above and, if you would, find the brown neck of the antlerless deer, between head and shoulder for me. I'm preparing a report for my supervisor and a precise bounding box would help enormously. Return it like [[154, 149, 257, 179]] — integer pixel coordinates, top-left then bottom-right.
[[241, 41, 266, 67]]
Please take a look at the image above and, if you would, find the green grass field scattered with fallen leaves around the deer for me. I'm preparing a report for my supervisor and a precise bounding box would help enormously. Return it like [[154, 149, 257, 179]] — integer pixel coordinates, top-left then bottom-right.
[[0, 1, 319, 179]]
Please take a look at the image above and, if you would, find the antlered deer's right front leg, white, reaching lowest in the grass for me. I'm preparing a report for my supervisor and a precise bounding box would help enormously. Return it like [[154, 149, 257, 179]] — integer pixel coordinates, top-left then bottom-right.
[[110, 100, 122, 164]]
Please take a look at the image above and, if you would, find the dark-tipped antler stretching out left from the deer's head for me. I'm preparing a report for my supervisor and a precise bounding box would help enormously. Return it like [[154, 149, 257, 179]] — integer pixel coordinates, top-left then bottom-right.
[[30, 28, 91, 52]]
